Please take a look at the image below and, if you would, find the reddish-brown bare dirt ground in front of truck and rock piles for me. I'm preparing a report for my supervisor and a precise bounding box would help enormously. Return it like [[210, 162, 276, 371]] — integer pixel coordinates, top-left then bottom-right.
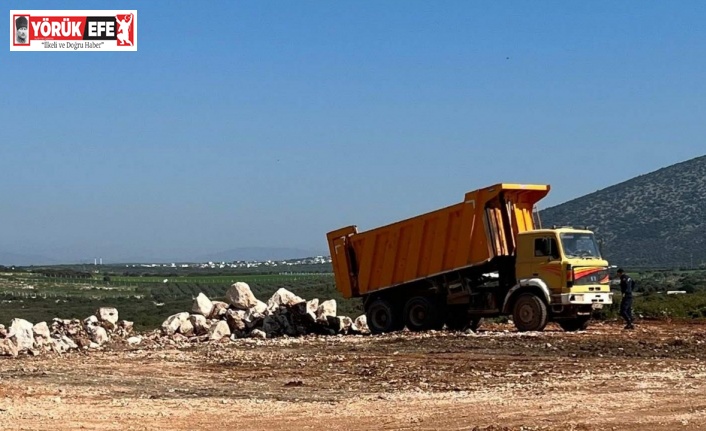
[[0, 322, 706, 431]]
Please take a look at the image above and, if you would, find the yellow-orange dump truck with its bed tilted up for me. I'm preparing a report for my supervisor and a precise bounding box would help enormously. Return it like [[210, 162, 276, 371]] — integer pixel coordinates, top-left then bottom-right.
[[327, 184, 612, 333]]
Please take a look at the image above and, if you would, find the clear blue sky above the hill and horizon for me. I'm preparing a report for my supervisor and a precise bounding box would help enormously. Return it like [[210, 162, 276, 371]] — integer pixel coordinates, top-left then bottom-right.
[[0, 0, 706, 264]]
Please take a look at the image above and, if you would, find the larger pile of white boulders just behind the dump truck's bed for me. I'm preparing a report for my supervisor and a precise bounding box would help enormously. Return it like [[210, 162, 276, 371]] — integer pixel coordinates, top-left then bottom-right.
[[162, 282, 369, 341]]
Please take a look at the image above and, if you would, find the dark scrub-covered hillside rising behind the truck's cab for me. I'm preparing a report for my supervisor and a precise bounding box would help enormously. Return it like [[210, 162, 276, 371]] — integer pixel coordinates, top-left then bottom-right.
[[540, 156, 706, 267]]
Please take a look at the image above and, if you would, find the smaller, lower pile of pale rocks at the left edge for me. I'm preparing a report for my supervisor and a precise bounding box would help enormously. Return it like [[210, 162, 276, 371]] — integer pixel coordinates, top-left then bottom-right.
[[0, 307, 133, 356]]
